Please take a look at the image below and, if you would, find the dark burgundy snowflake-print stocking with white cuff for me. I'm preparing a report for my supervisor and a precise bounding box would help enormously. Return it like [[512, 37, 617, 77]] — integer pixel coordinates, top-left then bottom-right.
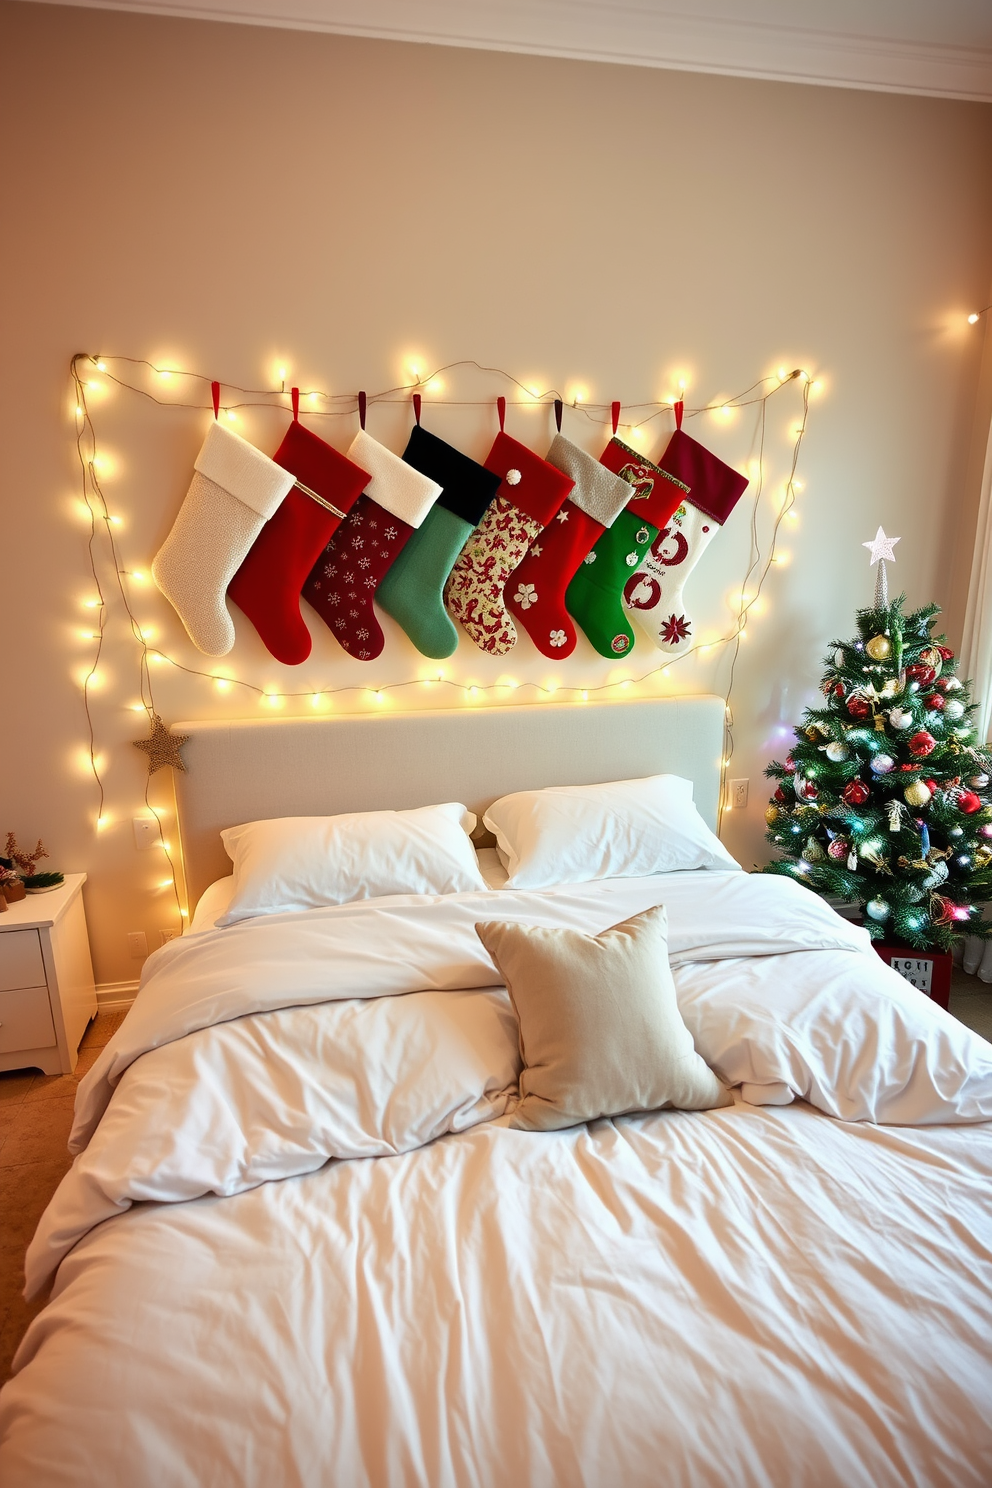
[[303, 429, 440, 661]]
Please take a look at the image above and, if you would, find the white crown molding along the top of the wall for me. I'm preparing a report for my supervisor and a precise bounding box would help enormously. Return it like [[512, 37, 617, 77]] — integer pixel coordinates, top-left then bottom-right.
[[19, 0, 992, 103]]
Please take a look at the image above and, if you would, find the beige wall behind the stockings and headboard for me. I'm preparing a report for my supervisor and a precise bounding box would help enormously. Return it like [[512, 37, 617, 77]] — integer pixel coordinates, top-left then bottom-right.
[[0, 4, 992, 982]]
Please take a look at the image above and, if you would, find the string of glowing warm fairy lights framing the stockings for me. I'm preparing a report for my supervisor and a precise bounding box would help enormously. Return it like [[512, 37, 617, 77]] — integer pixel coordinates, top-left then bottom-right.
[[70, 353, 819, 918]]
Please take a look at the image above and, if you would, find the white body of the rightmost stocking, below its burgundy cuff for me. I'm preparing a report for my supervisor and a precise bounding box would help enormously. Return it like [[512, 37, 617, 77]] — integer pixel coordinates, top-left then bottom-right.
[[623, 501, 720, 653]]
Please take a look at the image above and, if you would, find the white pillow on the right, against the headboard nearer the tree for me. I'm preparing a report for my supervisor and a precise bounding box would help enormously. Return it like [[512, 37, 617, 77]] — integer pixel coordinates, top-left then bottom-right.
[[483, 775, 741, 888]]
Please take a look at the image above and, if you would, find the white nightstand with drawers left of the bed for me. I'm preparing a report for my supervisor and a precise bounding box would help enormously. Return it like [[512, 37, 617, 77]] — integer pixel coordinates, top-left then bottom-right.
[[0, 873, 97, 1074]]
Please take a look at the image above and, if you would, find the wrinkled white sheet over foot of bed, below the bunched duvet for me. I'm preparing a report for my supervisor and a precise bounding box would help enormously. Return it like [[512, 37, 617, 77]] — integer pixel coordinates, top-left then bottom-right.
[[0, 1106, 992, 1488]]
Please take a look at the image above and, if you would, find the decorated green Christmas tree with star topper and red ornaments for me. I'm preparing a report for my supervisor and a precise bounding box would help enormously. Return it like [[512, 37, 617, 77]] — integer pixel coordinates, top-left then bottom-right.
[[764, 527, 992, 951]]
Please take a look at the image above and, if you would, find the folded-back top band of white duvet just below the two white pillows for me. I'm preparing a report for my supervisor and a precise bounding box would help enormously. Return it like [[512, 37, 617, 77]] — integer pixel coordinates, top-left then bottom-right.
[[68, 872, 872, 1152]]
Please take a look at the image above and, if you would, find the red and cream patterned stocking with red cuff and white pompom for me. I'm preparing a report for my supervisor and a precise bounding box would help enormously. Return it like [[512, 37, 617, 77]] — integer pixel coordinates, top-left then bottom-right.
[[445, 430, 573, 656]]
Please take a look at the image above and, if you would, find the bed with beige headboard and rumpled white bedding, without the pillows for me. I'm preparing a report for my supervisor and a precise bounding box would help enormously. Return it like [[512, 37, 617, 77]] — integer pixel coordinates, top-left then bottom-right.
[[0, 698, 992, 1488]]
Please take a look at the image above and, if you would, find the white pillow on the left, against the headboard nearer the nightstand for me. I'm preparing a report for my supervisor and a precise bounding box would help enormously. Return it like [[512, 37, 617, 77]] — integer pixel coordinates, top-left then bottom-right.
[[216, 802, 486, 926]]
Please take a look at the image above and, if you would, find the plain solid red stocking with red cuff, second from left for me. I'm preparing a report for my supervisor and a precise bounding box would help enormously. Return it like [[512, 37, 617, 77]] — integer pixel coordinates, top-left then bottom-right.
[[228, 420, 369, 667]]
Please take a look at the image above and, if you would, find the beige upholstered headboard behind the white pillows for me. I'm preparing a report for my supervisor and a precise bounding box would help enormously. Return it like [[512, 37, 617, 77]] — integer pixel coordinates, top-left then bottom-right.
[[174, 696, 724, 905]]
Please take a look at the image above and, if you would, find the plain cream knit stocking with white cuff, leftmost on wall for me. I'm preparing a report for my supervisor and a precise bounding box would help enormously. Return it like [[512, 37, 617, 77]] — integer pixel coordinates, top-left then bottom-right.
[[152, 421, 293, 656]]
